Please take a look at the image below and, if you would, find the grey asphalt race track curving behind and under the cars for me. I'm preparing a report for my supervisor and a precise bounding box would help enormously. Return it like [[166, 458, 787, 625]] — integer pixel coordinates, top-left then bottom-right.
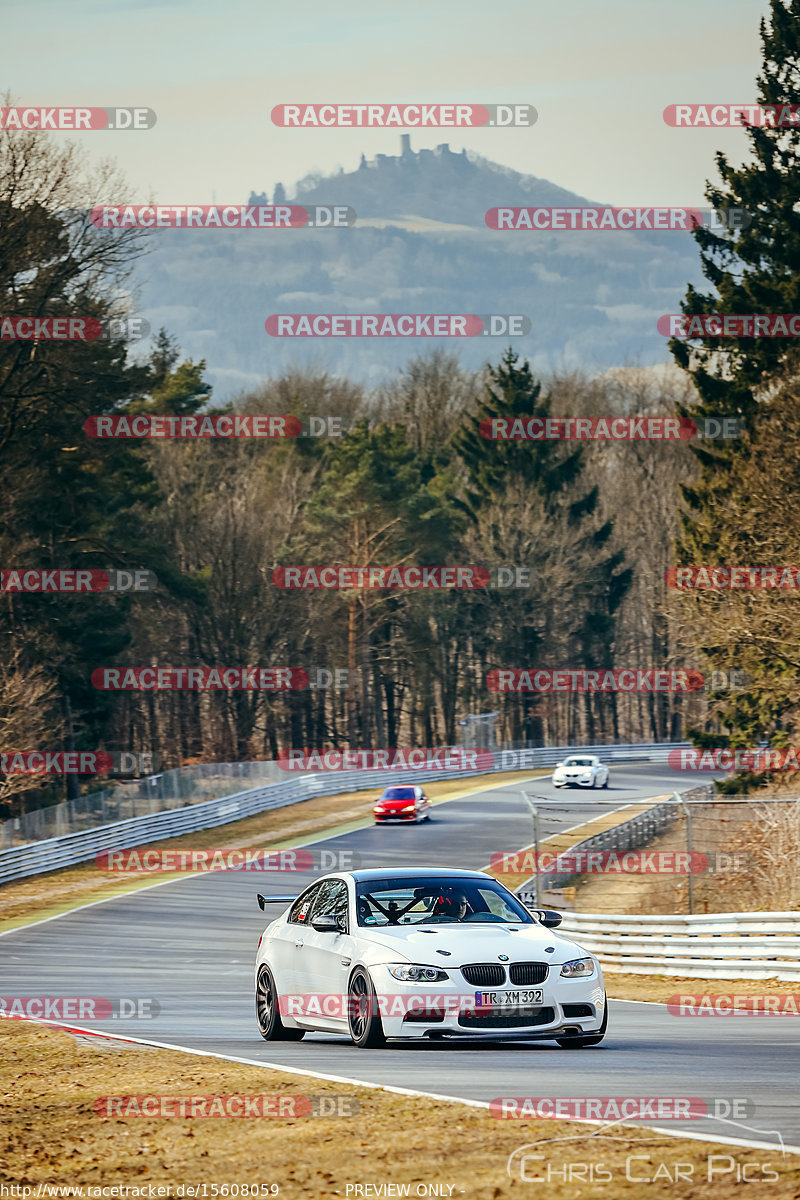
[[0, 764, 800, 1153]]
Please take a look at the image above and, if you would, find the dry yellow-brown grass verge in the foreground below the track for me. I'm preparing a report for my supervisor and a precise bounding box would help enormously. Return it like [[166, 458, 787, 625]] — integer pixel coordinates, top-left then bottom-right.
[[0, 1020, 800, 1200]]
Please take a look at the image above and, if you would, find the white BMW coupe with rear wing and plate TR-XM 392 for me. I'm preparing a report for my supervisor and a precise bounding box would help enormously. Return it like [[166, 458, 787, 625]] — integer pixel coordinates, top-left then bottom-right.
[[255, 868, 607, 1048]]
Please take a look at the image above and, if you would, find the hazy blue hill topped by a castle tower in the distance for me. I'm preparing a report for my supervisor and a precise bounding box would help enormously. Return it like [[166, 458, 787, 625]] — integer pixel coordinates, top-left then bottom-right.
[[138, 136, 700, 400]]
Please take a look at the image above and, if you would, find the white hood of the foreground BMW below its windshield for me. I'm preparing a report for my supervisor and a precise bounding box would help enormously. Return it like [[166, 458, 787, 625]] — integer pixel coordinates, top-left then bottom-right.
[[359, 925, 589, 970]]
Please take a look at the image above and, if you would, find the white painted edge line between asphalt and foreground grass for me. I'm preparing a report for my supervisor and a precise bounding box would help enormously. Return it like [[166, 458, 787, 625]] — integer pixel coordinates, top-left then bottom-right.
[[0, 1013, 800, 1154]]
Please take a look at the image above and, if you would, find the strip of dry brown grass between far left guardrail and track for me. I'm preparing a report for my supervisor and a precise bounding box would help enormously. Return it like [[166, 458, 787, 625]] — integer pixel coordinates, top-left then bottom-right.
[[0, 769, 549, 932]]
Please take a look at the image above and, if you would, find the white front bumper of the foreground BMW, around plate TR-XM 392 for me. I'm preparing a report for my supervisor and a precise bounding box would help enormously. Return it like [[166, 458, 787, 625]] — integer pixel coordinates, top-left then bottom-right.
[[369, 964, 606, 1040]]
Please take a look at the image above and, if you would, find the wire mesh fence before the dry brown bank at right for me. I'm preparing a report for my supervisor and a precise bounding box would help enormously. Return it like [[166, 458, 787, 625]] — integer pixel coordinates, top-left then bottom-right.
[[513, 786, 800, 918]]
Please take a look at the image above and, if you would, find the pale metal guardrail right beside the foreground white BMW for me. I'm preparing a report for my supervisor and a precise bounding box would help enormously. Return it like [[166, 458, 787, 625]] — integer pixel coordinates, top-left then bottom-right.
[[559, 912, 800, 980]]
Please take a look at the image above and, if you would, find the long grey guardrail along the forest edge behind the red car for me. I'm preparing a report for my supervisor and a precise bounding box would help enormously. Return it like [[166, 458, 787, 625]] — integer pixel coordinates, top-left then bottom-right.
[[0, 742, 690, 884]]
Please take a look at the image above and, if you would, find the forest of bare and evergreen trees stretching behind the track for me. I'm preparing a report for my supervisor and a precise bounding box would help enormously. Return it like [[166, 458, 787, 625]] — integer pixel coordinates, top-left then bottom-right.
[[0, 0, 800, 815]]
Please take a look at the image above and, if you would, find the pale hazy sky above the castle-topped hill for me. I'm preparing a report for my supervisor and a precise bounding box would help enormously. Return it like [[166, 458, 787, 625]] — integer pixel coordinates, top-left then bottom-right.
[[0, 0, 769, 206]]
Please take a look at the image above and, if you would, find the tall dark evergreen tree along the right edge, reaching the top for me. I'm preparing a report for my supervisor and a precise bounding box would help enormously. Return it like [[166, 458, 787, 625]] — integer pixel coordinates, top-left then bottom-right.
[[670, 0, 800, 768]]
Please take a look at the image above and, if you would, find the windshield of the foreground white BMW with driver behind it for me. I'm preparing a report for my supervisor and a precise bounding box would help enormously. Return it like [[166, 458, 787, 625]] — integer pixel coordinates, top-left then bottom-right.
[[356, 875, 534, 926]]
